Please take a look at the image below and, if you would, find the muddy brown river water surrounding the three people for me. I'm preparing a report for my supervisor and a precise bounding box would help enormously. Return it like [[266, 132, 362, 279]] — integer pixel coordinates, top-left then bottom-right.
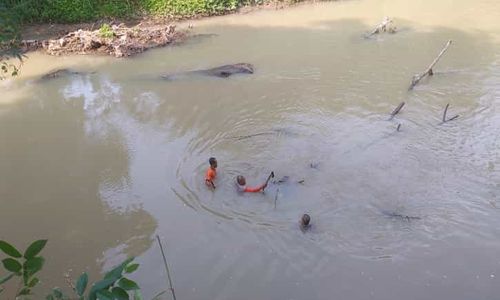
[[0, 0, 500, 300]]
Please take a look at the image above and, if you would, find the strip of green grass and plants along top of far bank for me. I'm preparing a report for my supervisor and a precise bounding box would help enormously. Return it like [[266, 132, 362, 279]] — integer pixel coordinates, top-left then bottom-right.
[[0, 0, 300, 24]]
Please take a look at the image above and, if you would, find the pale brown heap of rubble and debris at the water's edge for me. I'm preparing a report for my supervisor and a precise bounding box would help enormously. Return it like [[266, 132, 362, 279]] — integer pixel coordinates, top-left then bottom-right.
[[22, 24, 185, 57]]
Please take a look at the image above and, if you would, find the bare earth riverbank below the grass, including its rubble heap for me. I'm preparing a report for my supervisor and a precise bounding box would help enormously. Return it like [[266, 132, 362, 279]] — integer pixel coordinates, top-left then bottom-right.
[[13, 1, 326, 57]]
